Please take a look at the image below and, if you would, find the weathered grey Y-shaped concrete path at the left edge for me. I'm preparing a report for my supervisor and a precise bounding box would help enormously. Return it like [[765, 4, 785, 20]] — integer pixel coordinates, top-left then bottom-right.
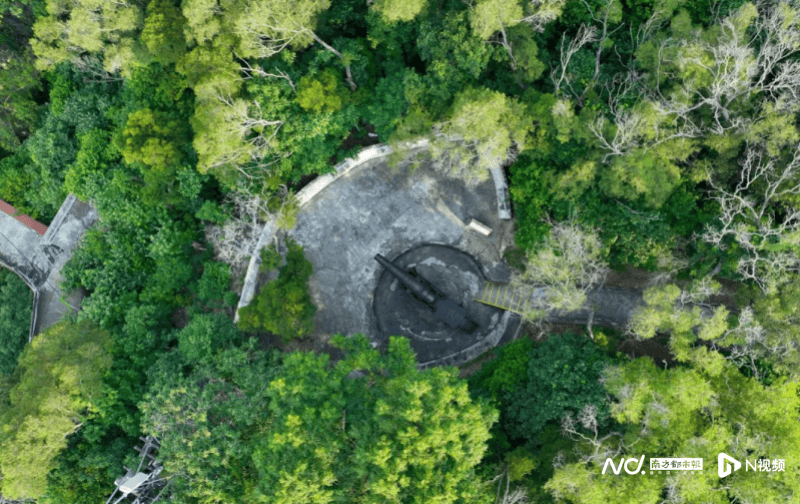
[[0, 194, 97, 338]]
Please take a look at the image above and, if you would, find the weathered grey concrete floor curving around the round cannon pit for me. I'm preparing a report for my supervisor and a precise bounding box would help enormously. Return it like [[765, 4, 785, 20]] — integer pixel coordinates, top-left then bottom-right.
[[288, 154, 513, 366]]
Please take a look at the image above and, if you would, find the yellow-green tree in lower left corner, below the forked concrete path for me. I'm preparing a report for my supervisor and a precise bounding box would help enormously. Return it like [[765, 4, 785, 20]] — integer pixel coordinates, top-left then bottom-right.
[[0, 322, 111, 499]]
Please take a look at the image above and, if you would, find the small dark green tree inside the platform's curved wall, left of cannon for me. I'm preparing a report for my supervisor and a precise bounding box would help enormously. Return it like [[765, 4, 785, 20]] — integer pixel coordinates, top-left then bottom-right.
[[234, 239, 317, 340]]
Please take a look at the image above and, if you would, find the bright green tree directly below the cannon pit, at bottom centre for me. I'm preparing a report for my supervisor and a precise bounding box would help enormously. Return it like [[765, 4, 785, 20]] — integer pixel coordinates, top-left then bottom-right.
[[253, 335, 497, 504]]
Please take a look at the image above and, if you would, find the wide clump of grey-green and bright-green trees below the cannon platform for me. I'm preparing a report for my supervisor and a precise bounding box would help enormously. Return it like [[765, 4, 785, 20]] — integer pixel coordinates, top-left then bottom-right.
[[141, 335, 493, 503]]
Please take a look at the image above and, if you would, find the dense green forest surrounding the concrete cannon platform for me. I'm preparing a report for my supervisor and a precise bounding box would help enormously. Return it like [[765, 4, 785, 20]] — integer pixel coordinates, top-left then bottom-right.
[[0, 0, 800, 504]]
